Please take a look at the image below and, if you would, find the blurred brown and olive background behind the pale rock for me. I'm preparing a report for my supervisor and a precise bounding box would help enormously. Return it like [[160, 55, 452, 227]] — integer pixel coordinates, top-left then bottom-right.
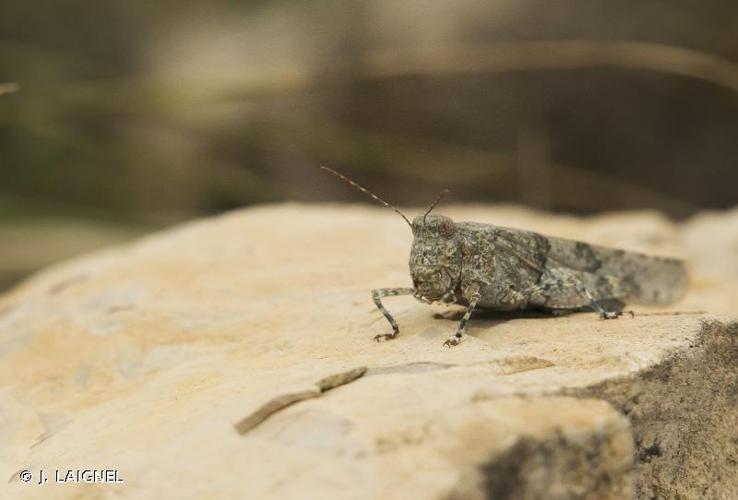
[[0, 0, 738, 289]]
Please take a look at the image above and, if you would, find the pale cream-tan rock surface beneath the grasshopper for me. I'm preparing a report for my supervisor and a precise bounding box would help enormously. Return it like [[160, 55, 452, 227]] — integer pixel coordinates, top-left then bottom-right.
[[0, 205, 738, 499]]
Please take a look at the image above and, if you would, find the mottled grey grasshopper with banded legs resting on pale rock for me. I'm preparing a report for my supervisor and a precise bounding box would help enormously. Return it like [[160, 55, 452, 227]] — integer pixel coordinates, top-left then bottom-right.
[[321, 167, 687, 346]]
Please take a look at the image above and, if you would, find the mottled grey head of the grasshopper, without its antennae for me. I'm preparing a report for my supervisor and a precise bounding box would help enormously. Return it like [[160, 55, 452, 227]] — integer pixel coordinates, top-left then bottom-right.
[[410, 215, 461, 301]]
